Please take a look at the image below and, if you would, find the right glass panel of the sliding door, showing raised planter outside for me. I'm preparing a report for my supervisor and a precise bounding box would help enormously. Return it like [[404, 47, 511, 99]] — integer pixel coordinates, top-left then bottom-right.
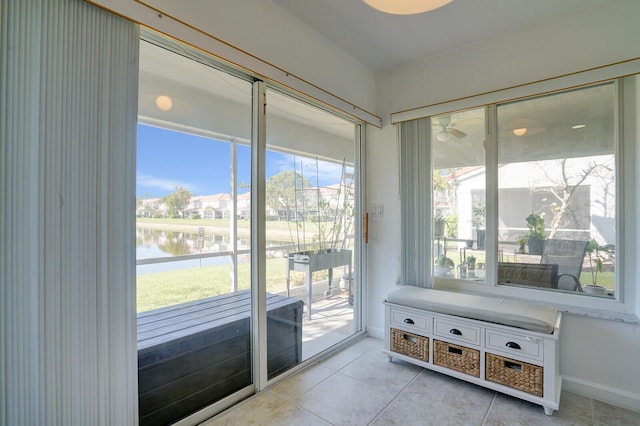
[[265, 90, 359, 370]]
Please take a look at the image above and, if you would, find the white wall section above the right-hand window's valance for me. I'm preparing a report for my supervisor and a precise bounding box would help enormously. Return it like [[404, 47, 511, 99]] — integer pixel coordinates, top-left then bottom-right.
[[377, 0, 640, 120]]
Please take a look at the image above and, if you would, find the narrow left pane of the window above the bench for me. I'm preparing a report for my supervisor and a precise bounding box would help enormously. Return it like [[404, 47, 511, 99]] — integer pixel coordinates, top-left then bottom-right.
[[431, 108, 486, 281]]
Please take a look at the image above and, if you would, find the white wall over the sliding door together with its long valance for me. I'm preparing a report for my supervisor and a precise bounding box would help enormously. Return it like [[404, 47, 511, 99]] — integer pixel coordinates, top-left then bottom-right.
[[87, 0, 379, 122]]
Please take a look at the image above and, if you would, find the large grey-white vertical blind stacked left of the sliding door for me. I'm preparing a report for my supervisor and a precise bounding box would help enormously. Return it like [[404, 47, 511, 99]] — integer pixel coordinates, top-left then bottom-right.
[[0, 0, 139, 425]]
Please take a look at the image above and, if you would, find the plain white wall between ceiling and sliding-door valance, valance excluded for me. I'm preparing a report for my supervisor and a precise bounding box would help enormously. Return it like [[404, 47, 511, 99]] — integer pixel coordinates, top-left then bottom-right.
[[159, 0, 376, 111]]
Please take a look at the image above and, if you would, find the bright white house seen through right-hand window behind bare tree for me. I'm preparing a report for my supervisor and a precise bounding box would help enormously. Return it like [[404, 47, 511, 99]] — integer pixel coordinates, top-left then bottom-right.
[[448, 155, 615, 244]]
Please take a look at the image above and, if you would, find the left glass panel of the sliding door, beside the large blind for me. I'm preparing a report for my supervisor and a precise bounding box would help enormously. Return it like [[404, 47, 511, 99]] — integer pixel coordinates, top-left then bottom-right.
[[136, 41, 253, 425]]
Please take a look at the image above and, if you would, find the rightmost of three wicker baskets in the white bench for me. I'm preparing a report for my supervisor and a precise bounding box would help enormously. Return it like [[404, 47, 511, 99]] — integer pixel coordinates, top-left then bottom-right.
[[485, 353, 544, 396]]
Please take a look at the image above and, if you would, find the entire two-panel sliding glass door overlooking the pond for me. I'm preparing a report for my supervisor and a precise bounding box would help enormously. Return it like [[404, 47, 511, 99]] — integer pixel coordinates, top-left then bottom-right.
[[136, 35, 361, 425]]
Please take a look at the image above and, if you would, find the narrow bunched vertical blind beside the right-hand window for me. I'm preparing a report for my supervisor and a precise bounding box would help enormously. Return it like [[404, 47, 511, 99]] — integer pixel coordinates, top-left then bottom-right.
[[398, 118, 432, 287]]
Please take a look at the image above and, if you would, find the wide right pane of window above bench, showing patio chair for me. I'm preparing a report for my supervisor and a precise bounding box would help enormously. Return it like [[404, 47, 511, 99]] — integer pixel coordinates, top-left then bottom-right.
[[497, 83, 616, 296]]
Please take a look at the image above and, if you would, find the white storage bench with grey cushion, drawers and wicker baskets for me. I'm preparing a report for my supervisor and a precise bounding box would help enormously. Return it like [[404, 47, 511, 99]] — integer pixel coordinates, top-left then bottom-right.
[[385, 286, 562, 415]]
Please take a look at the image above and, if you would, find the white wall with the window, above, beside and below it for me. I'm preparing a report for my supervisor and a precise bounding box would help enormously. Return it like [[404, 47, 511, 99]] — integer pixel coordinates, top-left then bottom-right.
[[367, 0, 640, 411]]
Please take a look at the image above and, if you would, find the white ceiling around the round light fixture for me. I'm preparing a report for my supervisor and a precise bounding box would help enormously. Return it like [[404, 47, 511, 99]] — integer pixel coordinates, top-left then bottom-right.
[[273, 0, 616, 71]]
